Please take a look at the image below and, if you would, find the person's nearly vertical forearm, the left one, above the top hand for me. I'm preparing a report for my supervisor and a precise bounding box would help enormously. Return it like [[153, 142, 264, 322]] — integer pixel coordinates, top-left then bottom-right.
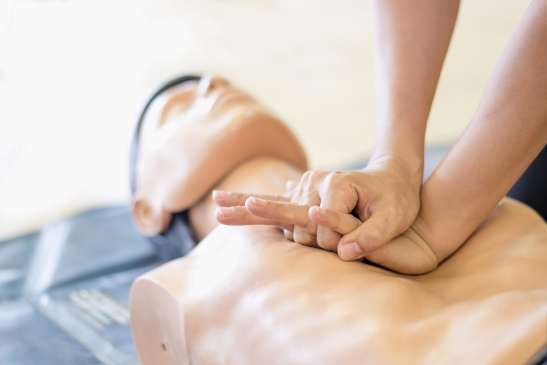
[[372, 0, 459, 174]]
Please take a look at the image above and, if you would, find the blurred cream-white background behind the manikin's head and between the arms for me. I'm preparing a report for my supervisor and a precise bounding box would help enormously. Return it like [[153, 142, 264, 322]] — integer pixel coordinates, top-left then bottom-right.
[[0, 0, 528, 240]]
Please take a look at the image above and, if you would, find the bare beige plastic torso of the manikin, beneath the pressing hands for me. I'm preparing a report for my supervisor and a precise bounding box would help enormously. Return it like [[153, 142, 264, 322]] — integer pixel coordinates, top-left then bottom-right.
[[131, 200, 547, 365]]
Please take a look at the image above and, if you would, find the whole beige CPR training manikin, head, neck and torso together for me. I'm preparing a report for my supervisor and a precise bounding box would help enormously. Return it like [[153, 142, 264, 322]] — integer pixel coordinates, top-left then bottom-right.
[[131, 76, 547, 364]]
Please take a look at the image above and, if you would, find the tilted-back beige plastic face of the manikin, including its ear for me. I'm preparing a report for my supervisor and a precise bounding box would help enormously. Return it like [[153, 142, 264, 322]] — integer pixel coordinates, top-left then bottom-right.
[[133, 75, 306, 235]]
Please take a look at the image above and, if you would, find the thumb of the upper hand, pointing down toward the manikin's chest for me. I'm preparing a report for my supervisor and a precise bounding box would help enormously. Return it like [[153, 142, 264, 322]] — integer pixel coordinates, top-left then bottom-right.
[[338, 213, 396, 261]]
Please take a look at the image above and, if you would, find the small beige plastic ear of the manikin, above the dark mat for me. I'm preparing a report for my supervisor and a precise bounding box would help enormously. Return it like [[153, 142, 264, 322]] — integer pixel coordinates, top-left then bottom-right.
[[133, 198, 173, 236]]
